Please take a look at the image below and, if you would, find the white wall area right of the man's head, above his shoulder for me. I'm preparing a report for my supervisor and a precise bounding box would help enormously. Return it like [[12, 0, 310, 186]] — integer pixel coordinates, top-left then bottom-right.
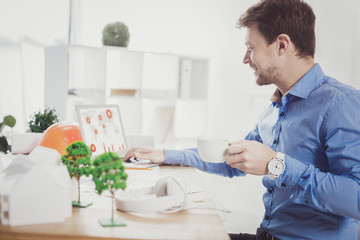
[[308, 0, 360, 88]]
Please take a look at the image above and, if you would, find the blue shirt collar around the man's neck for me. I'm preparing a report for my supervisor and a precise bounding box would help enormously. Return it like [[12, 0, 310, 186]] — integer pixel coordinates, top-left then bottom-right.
[[270, 63, 325, 102]]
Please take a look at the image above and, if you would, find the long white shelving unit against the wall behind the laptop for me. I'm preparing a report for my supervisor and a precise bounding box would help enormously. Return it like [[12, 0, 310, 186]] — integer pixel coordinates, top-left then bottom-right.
[[45, 45, 209, 146]]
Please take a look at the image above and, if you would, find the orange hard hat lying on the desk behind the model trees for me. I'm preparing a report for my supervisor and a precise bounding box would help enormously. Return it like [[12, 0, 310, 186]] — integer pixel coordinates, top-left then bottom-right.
[[39, 122, 82, 156]]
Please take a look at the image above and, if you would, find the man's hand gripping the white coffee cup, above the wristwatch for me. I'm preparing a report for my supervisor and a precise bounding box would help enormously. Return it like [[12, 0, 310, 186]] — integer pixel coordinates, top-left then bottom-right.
[[226, 140, 276, 175]]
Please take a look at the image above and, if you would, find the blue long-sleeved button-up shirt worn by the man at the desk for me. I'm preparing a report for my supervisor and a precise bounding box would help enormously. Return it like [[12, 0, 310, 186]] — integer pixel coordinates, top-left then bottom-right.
[[165, 64, 360, 240]]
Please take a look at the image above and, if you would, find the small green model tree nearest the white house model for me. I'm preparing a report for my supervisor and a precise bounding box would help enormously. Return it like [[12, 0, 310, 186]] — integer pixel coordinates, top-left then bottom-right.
[[61, 141, 92, 207]]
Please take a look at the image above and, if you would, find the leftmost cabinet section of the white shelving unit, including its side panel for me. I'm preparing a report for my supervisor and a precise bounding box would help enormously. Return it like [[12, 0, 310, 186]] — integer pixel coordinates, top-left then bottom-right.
[[44, 45, 106, 120]]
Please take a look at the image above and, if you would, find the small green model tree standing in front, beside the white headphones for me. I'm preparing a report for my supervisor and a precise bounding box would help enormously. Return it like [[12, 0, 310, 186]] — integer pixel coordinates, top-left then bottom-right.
[[92, 152, 127, 227]]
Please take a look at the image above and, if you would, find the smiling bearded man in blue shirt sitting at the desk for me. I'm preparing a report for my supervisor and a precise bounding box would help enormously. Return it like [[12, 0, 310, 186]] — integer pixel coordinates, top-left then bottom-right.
[[125, 0, 360, 239]]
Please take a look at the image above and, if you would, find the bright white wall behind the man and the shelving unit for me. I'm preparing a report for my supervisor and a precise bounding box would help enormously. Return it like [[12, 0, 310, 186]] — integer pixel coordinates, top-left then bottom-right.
[[0, 0, 360, 232]]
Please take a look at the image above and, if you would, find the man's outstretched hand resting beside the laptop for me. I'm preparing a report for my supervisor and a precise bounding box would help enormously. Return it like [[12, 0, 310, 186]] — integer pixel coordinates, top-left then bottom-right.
[[123, 147, 165, 163]]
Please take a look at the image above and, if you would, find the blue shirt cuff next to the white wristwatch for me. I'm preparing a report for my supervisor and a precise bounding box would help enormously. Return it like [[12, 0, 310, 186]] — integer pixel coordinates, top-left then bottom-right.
[[275, 155, 308, 192]]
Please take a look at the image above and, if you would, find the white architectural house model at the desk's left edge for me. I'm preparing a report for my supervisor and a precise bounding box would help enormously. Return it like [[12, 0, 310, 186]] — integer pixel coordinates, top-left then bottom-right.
[[0, 147, 72, 226]]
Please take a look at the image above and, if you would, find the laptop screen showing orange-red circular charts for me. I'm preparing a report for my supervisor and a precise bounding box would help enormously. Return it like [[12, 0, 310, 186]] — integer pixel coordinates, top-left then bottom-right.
[[76, 105, 128, 157]]
